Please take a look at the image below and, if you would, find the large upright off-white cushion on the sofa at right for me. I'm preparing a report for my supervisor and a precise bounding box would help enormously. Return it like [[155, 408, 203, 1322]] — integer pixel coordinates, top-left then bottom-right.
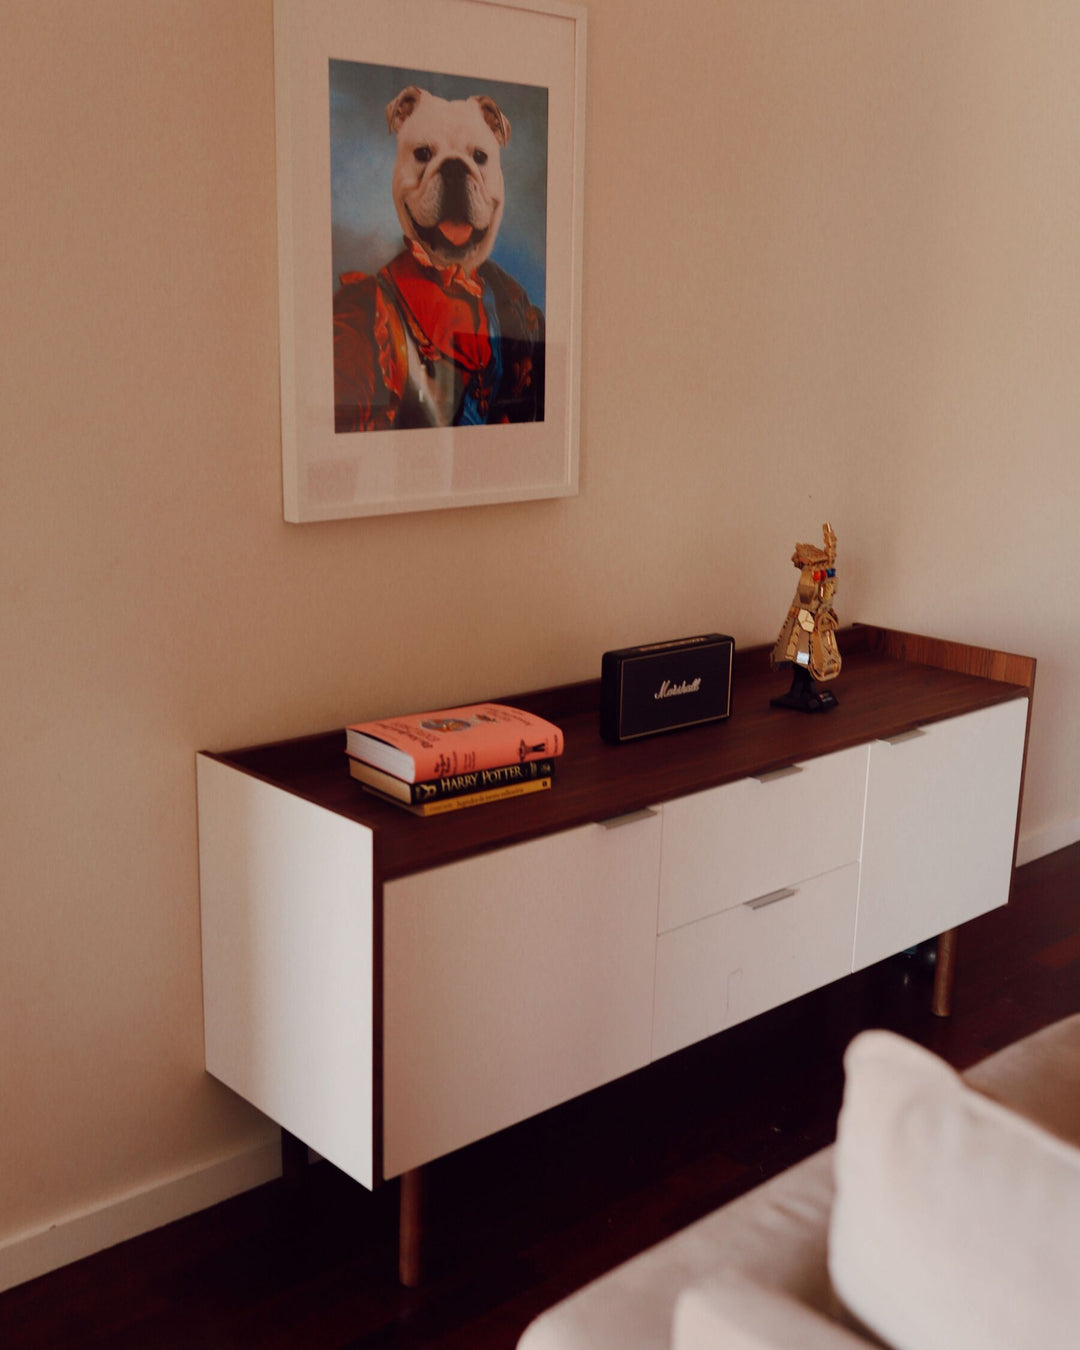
[[829, 1031, 1080, 1350]]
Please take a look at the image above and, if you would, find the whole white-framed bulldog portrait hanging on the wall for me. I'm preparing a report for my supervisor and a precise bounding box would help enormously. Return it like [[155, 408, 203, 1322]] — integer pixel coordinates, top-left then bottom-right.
[[274, 0, 586, 521]]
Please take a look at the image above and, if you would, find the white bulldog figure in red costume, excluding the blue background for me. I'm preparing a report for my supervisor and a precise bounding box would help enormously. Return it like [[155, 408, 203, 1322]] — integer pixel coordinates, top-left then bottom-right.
[[333, 85, 544, 432]]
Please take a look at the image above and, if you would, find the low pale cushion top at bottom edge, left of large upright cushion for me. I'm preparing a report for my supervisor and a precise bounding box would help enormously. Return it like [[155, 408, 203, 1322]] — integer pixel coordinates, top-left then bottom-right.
[[671, 1269, 879, 1350]]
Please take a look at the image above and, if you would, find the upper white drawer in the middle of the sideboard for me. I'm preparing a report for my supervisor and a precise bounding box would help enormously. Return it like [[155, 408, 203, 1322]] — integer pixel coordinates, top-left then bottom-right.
[[657, 745, 868, 933]]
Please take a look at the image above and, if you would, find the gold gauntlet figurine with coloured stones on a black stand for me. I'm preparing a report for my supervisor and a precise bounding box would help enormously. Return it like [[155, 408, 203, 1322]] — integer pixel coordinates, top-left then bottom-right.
[[772, 521, 840, 713]]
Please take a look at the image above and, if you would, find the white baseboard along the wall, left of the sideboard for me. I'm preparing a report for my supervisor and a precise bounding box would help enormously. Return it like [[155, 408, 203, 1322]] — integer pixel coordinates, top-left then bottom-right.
[[0, 1141, 281, 1292]]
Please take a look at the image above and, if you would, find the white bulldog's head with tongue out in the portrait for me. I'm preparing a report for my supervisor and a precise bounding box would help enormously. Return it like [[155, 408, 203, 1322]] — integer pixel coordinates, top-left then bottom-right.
[[386, 85, 510, 274]]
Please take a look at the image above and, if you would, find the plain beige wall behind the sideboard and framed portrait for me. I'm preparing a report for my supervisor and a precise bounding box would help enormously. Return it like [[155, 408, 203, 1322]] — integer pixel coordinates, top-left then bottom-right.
[[0, 0, 1080, 1263]]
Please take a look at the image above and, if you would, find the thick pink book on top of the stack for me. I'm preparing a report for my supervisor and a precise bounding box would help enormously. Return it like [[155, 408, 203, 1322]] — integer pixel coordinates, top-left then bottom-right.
[[346, 703, 563, 783]]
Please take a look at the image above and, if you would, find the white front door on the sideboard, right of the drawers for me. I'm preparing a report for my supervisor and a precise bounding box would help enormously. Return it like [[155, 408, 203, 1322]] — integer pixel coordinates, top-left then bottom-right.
[[852, 698, 1027, 971]]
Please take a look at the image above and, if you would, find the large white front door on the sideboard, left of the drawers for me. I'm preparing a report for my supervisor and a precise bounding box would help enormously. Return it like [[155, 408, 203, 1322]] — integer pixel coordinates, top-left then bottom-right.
[[383, 813, 660, 1177]]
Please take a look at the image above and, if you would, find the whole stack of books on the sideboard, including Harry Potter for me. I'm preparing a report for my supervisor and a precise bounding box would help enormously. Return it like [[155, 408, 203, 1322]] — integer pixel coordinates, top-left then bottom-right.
[[346, 703, 563, 815]]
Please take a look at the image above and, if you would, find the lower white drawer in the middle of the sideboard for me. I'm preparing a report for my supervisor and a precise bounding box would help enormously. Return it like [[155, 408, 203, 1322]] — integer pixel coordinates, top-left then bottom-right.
[[652, 863, 859, 1060]]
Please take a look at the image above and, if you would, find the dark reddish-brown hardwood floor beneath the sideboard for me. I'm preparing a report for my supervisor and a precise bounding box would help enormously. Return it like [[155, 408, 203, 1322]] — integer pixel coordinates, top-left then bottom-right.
[[0, 845, 1080, 1350]]
